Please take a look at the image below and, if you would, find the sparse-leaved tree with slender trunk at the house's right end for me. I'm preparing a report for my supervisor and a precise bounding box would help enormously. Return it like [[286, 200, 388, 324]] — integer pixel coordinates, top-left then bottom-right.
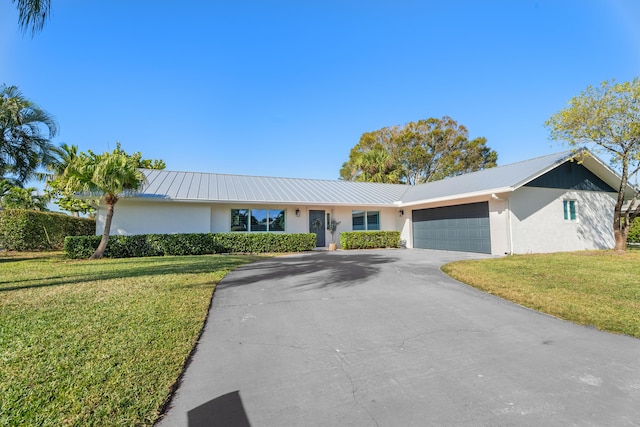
[[545, 77, 640, 251]]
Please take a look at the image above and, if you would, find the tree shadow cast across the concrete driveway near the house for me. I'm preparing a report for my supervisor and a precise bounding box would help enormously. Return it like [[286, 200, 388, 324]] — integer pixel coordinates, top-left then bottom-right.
[[217, 251, 396, 289]]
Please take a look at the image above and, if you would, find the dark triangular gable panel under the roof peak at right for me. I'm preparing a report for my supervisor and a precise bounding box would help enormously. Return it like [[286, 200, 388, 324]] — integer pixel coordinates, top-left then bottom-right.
[[525, 162, 617, 193]]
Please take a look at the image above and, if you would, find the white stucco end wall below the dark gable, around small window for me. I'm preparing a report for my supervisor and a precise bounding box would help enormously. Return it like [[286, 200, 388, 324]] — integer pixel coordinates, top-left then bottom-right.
[[509, 187, 615, 254]]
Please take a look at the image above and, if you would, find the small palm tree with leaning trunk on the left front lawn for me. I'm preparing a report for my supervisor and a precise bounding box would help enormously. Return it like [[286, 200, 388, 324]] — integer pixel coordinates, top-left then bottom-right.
[[56, 146, 145, 259]]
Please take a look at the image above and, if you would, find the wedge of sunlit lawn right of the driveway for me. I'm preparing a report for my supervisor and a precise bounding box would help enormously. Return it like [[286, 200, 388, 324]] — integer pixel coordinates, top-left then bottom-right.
[[443, 250, 640, 338]]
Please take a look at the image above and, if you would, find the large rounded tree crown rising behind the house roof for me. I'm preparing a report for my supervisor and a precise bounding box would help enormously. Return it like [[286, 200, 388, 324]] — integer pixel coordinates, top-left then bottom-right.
[[340, 116, 498, 184]]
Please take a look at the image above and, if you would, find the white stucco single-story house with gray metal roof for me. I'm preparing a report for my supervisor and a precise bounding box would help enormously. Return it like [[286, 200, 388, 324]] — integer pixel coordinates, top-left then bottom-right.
[[96, 151, 633, 255]]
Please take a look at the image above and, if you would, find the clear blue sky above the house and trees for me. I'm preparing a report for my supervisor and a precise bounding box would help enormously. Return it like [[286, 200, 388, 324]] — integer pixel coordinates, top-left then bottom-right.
[[0, 0, 640, 179]]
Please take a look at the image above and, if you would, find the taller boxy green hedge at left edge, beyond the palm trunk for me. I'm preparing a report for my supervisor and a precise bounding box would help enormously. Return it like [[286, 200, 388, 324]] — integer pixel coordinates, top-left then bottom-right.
[[0, 209, 96, 251]]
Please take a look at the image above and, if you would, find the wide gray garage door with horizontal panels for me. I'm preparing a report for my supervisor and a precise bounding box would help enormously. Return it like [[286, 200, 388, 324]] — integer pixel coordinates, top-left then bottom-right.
[[412, 202, 491, 254]]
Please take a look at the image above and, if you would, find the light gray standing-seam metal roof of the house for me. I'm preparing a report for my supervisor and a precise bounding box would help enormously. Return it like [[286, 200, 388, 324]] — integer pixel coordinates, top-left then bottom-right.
[[134, 151, 617, 206]]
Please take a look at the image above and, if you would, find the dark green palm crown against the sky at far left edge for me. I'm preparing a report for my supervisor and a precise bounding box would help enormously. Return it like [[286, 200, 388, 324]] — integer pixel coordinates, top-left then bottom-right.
[[0, 85, 58, 183]]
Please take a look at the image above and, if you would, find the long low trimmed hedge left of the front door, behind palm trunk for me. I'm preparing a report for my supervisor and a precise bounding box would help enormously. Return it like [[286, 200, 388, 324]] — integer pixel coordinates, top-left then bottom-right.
[[64, 233, 316, 259]]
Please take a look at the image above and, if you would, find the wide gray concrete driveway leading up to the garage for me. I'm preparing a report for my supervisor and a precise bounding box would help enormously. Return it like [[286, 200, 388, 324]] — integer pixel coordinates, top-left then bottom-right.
[[160, 250, 640, 427]]
